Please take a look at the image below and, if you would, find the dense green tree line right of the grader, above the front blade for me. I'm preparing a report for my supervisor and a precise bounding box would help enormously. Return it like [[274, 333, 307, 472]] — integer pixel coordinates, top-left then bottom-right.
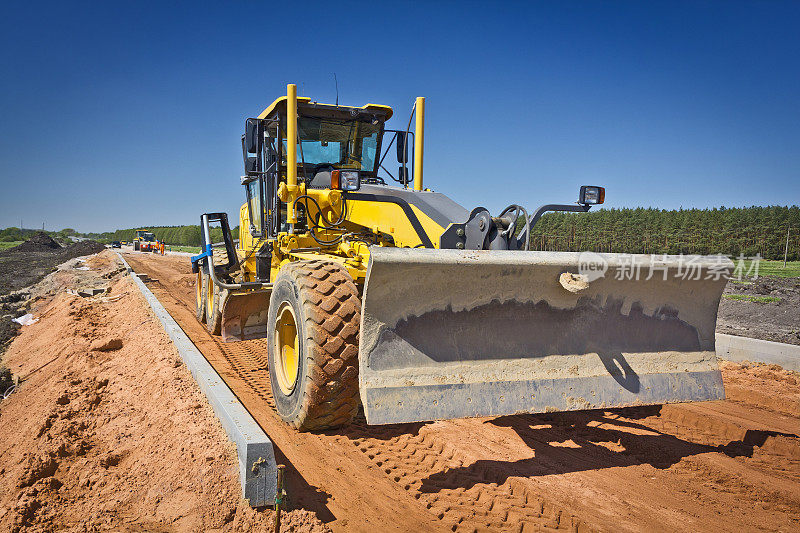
[[530, 205, 800, 261]]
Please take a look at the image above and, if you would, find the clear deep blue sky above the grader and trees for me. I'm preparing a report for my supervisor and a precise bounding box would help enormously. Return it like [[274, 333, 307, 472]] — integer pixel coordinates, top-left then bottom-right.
[[0, 1, 800, 231]]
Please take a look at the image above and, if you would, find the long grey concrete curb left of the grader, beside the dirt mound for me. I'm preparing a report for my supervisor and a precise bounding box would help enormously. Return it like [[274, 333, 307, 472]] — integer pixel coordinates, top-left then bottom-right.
[[117, 252, 277, 507]]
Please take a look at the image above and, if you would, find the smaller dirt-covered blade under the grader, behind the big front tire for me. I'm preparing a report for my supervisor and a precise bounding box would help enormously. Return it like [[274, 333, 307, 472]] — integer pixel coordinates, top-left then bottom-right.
[[220, 289, 272, 342]]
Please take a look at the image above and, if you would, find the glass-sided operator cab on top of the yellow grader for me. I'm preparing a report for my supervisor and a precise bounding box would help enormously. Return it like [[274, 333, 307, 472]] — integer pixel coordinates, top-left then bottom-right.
[[242, 96, 413, 236]]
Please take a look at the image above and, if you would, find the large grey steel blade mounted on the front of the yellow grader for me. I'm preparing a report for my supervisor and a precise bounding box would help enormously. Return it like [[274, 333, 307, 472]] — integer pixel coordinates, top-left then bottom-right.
[[359, 247, 733, 424]]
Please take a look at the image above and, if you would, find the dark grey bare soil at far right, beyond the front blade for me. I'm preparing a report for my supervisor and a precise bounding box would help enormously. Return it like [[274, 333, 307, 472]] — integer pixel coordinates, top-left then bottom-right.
[[717, 277, 800, 344]]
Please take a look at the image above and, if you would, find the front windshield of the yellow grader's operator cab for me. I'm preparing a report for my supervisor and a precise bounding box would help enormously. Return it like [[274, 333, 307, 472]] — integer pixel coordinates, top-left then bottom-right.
[[283, 117, 381, 172]]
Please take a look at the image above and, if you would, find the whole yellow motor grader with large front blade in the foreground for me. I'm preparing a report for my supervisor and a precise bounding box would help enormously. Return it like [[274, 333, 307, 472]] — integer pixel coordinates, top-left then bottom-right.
[[192, 85, 733, 430]]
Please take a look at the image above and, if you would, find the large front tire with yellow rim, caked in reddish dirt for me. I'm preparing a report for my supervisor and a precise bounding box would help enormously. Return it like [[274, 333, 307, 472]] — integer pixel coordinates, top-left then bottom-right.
[[267, 261, 361, 431]]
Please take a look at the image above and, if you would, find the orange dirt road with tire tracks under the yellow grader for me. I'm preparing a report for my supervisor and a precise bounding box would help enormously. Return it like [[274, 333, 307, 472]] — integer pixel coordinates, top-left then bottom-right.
[[126, 254, 800, 532]]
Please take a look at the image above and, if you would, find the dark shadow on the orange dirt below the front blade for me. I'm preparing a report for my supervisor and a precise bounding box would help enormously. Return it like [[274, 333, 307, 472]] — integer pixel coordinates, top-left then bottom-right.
[[420, 406, 796, 493]]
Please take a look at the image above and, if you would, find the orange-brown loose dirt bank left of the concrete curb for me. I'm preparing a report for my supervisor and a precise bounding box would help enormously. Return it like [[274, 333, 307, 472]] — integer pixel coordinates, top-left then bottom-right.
[[0, 251, 328, 532]]
